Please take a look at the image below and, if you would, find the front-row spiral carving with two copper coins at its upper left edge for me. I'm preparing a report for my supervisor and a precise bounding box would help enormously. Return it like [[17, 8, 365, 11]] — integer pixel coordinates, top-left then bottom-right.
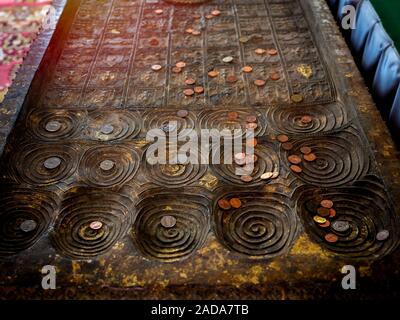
[[213, 186, 297, 258]]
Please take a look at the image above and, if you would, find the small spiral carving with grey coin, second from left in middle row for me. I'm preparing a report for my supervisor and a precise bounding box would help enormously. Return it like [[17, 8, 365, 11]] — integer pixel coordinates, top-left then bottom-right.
[[79, 145, 140, 187]]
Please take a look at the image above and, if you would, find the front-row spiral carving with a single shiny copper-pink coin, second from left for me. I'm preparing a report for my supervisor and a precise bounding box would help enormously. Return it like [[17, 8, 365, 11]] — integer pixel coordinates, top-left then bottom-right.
[[51, 188, 134, 259]]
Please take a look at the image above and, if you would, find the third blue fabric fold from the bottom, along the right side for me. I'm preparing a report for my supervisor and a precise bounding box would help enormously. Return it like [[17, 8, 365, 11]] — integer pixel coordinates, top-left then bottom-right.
[[361, 23, 393, 83]]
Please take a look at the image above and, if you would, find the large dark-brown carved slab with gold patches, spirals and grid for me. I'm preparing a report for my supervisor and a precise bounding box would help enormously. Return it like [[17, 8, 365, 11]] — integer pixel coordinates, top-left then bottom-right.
[[0, 0, 400, 299]]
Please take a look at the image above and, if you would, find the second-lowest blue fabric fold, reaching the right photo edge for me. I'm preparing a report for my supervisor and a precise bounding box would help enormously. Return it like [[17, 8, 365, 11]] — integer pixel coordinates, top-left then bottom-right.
[[372, 46, 400, 119]]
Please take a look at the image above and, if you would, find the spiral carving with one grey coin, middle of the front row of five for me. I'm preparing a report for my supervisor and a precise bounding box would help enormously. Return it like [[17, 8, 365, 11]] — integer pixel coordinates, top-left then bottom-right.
[[132, 188, 210, 262]]
